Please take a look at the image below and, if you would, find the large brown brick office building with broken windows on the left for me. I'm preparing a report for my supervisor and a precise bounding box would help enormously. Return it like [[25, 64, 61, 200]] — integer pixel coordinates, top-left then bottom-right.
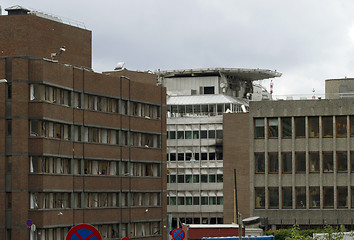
[[0, 6, 167, 240]]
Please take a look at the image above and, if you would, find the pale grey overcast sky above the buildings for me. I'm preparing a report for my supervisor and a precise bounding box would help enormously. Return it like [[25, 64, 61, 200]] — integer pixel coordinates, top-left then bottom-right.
[[0, 0, 354, 95]]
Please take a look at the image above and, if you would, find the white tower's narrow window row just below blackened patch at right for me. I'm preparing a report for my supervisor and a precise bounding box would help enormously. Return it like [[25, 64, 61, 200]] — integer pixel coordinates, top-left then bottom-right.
[[167, 152, 223, 161]]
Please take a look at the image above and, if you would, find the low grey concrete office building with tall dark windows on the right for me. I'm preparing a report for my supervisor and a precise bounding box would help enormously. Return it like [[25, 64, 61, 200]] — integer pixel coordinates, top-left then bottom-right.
[[224, 79, 354, 228]]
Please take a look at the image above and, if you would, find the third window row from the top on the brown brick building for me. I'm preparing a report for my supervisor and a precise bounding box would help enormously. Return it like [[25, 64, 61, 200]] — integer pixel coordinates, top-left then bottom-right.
[[30, 156, 161, 177]]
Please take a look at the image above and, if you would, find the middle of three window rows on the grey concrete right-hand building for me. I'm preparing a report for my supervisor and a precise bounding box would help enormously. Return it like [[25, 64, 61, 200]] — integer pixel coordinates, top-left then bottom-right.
[[254, 151, 354, 173]]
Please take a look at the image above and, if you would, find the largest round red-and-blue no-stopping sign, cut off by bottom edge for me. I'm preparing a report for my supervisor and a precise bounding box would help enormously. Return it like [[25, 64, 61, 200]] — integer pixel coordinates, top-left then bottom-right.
[[66, 224, 102, 240]]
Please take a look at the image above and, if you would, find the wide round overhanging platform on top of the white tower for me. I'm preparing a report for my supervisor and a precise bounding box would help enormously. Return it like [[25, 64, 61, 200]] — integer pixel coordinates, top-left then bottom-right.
[[156, 68, 282, 81]]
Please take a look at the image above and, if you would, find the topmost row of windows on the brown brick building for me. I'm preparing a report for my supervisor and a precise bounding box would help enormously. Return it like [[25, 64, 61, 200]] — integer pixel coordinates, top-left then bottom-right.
[[30, 84, 161, 119]]
